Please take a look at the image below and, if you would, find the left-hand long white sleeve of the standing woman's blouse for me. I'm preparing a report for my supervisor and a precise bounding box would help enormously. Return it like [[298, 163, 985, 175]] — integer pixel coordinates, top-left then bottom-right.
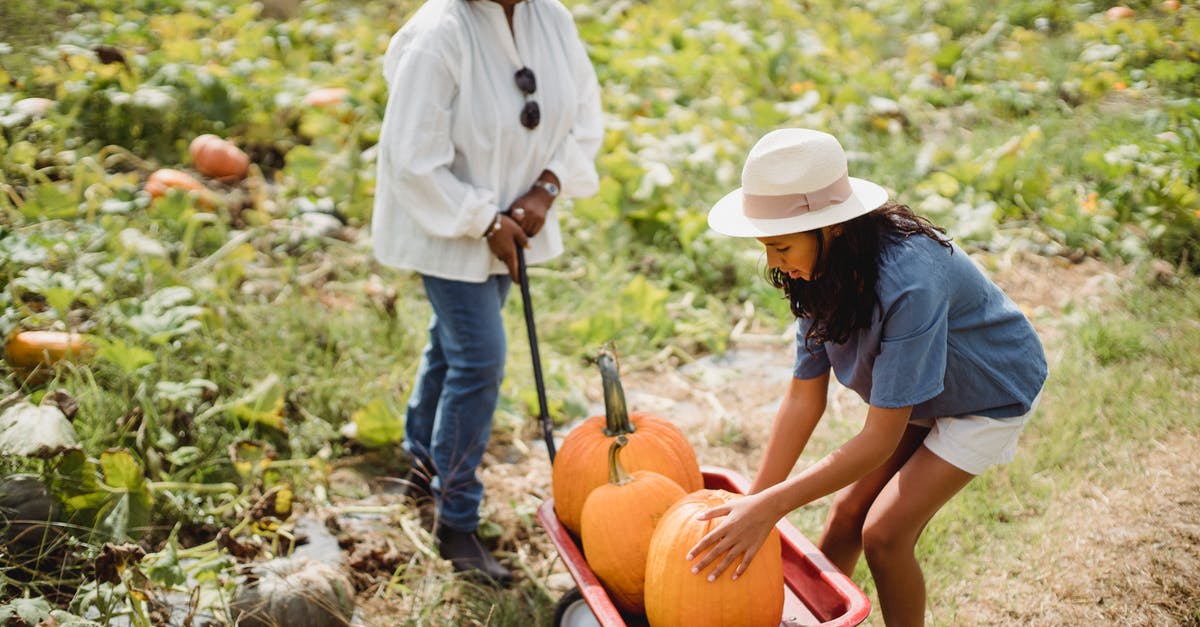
[[379, 48, 499, 238]]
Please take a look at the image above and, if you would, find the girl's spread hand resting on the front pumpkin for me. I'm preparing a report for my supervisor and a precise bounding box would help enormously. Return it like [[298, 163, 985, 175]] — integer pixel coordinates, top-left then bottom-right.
[[688, 494, 782, 581]]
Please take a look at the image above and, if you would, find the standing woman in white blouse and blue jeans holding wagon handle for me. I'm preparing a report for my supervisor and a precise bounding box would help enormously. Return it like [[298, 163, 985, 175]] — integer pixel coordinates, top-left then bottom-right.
[[372, 0, 602, 583]]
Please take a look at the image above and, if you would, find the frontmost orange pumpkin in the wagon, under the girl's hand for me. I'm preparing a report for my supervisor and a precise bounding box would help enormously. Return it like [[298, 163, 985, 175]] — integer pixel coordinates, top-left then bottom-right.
[[646, 490, 784, 627]]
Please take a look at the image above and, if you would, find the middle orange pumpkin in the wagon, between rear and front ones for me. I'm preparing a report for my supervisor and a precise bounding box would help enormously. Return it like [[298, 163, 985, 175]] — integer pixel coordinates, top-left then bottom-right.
[[580, 435, 686, 614]]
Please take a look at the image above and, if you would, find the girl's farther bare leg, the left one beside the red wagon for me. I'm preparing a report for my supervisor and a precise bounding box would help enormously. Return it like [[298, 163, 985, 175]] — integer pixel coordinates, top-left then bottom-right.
[[817, 425, 929, 575]]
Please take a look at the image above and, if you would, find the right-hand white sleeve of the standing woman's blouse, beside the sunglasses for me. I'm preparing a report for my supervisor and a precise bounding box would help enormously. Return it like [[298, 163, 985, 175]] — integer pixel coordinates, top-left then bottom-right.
[[546, 22, 604, 198]]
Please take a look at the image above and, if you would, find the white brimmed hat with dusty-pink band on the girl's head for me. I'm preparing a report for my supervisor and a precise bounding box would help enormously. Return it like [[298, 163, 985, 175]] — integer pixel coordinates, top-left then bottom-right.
[[708, 129, 888, 238]]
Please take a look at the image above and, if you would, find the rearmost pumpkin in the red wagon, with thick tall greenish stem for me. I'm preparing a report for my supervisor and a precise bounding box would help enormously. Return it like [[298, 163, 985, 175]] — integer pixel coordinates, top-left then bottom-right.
[[552, 351, 704, 535]]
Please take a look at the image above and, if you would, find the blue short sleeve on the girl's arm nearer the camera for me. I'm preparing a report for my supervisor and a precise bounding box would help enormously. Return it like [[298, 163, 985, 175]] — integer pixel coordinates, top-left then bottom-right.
[[870, 281, 949, 407]]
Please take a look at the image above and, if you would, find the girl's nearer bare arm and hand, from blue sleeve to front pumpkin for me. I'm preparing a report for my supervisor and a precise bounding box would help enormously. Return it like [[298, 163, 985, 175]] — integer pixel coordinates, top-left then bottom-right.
[[688, 405, 912, 581]]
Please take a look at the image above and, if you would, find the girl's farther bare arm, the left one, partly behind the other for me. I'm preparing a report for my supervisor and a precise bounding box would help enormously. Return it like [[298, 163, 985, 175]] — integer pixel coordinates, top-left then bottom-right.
[[750, 371, 829, 494]]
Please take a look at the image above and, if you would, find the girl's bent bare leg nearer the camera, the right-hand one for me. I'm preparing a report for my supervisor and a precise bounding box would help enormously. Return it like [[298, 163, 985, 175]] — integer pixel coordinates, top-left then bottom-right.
[[863, 447, 974, 627]]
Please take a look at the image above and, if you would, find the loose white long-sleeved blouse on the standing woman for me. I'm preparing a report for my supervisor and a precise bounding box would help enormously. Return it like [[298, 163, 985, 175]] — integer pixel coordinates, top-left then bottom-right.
[[371, 0, 604, 282]]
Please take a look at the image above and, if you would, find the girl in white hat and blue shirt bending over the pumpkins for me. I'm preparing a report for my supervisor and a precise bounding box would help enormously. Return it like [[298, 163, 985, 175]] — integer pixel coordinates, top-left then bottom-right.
[[688, 129, 1046, 625]]
